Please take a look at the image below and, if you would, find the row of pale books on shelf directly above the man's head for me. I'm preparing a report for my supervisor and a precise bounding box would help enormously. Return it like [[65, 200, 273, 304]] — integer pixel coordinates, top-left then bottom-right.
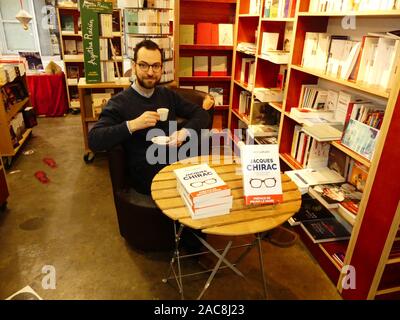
[[124, 9, 170, 34]]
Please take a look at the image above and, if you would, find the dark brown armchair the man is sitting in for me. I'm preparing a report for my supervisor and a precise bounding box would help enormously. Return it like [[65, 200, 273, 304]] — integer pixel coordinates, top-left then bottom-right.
[[108, 88, 213, 251]]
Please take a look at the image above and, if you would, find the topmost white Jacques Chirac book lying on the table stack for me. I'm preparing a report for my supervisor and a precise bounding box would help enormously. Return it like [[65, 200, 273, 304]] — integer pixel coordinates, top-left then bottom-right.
[[174, 164, 231, 202]]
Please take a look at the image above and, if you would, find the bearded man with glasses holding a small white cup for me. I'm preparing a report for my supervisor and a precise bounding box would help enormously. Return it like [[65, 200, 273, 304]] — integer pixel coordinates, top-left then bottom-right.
[[89, 40, 209, 194]]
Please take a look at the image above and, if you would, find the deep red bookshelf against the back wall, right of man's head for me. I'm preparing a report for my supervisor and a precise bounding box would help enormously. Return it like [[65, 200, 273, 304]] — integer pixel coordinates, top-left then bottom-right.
[[175, 0, 236, 130]]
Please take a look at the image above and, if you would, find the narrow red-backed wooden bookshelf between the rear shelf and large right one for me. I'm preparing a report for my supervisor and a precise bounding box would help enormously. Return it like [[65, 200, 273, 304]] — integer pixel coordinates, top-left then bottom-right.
[[229, 0, 295, 145]]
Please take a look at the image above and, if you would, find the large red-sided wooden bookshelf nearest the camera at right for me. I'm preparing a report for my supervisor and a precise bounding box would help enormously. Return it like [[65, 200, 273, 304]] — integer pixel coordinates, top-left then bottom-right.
[[279, 0, 400, 299]]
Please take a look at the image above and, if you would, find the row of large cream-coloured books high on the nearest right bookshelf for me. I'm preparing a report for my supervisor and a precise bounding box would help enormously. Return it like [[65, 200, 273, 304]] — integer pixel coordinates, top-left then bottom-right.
[[302, 32, 400, 89]]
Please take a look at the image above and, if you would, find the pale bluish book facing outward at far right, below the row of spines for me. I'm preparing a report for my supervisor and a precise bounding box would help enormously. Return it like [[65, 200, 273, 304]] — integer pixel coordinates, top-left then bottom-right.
[[341, 119, 379, 160]]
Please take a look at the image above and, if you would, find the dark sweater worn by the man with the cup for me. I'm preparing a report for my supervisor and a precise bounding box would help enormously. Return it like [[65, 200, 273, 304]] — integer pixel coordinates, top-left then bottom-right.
[[88, 86, 209, 167]]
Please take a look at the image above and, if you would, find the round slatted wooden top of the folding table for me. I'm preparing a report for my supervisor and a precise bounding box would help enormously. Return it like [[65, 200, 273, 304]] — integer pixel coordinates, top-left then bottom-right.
[[151, 156, 301, 236]]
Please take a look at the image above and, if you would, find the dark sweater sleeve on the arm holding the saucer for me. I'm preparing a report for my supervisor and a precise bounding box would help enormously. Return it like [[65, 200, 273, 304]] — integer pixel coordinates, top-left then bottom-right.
[[172, 92, 210, 132]]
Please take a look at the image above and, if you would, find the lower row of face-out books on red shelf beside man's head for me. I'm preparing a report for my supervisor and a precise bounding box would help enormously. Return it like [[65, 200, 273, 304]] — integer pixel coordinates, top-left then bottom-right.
[[179, 56, 228, 77]]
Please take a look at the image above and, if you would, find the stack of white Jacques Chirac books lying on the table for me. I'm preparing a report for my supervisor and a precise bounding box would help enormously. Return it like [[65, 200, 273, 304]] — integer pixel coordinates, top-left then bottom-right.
[[174, 164, 233, 219]]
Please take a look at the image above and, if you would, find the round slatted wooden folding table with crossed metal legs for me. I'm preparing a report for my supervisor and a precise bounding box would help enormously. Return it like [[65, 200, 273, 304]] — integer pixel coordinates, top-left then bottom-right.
[[151, 156, 301, 299]]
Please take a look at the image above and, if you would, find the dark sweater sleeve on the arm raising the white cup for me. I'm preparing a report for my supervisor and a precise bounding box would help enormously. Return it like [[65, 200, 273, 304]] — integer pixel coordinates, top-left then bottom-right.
[[88, 99, 131, 151]]
